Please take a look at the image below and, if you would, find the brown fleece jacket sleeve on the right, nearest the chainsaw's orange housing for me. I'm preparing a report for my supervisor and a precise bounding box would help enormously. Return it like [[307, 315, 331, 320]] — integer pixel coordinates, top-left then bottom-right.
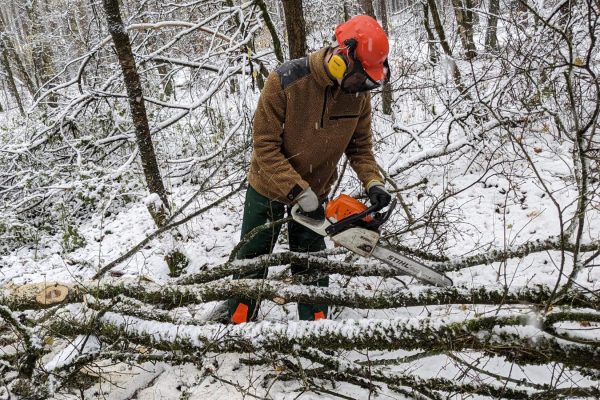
[[346, 93, 383, 189]]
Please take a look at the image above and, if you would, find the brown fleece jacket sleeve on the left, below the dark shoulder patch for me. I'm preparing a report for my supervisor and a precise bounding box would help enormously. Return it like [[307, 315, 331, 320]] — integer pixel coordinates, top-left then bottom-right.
[[252, 71, 309, 201]]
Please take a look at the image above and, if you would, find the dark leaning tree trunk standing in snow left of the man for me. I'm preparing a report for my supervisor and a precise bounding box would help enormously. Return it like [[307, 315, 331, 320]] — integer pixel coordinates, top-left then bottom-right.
[[103, 0, 169, 226]]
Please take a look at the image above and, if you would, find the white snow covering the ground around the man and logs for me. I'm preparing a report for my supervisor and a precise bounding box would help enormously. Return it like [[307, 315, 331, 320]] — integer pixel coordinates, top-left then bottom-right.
[[0, 3, 600, 400]]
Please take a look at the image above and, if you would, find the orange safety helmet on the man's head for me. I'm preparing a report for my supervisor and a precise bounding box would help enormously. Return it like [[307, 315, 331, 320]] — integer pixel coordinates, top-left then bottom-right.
[[335, 15, 390, 81]]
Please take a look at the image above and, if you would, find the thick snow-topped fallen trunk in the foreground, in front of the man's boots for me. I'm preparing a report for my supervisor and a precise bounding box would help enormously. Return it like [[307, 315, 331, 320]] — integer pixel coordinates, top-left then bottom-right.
[[49, 306, 600, 369]]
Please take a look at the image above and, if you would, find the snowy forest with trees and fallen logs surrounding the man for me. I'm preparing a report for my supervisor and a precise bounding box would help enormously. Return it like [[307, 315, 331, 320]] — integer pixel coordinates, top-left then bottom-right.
[[0, 0, 600, 399]]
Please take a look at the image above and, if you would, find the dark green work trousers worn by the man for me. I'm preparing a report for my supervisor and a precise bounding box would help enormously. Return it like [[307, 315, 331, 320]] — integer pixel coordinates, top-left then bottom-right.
[[228, 186, 329, 321]]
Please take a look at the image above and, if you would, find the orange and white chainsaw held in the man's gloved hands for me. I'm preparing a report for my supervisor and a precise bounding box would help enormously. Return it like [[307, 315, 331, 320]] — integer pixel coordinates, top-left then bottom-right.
[[291, 194, 452, 286]]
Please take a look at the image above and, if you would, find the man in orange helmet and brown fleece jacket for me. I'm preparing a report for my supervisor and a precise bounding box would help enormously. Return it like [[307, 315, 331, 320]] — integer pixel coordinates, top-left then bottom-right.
[[229, 15, 391, 323]]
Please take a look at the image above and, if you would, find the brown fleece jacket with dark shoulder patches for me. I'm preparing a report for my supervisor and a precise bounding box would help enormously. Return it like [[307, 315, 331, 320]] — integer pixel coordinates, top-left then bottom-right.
[[248, 48, 383, 204]]
